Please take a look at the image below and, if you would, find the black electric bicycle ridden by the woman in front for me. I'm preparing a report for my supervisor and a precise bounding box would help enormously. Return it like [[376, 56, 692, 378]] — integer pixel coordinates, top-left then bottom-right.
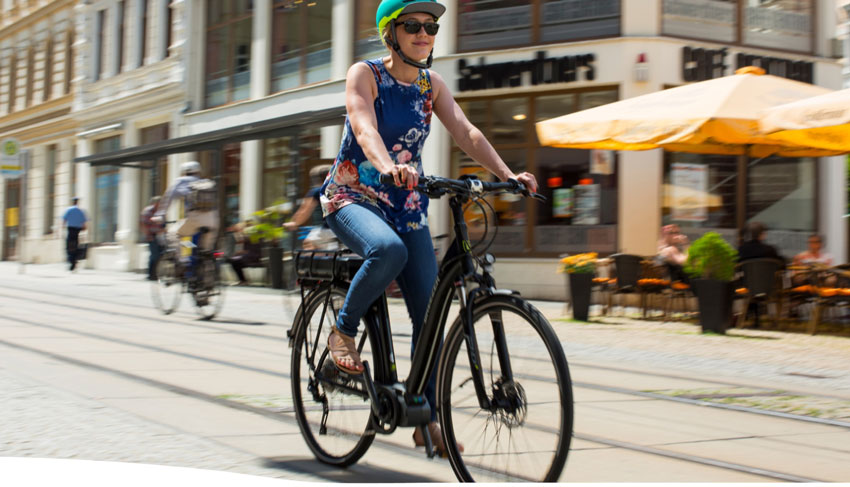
[[289, 177, 573, 481]]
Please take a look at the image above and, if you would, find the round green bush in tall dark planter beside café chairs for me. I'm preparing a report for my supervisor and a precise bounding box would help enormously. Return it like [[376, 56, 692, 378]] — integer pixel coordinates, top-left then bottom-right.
[[685, 232, 738, 334]]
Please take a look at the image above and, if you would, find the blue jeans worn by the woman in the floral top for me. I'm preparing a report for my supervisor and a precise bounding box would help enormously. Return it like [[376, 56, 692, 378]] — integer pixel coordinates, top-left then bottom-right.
[[325, 204, 437, 421]]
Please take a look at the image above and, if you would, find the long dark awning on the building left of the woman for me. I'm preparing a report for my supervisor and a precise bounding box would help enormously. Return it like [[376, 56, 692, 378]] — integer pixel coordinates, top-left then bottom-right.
[[74, 107, 345, 169]]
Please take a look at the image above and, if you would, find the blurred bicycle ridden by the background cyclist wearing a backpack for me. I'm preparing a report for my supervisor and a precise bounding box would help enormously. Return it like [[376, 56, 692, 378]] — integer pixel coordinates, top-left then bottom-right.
[[151, 227, 224, 320]]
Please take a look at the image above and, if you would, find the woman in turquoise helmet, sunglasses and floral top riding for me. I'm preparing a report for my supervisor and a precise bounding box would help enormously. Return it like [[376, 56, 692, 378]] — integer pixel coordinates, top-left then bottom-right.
[[321, 0, 537, 454]]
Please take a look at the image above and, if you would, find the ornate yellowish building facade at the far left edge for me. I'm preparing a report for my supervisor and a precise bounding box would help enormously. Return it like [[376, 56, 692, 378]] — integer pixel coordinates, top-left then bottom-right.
[[0, 0, 76, 262]]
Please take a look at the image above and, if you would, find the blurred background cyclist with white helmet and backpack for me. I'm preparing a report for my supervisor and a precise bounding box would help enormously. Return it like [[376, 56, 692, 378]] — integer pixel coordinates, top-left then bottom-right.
[[151, 161, 218, 260]]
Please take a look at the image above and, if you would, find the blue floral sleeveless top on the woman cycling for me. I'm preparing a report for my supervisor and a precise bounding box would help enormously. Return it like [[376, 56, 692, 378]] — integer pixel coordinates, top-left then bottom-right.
[[321, 59, 432, 233]]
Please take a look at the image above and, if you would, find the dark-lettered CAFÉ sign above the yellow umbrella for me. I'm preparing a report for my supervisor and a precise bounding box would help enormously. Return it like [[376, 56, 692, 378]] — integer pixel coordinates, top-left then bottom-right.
[[682, 46, 814, 83]]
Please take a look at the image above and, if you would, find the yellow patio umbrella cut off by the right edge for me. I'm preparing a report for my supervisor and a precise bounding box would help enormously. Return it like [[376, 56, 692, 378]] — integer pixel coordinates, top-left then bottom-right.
[[761, 89, 850, 152]]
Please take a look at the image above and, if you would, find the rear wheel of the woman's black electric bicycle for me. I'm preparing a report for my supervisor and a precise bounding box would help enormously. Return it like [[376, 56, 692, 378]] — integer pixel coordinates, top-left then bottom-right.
[[290, 287, 375, 467]]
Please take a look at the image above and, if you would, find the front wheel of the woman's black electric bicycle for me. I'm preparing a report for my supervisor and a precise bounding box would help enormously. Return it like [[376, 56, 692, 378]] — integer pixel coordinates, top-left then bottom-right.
[[437, 296, 573, 482]]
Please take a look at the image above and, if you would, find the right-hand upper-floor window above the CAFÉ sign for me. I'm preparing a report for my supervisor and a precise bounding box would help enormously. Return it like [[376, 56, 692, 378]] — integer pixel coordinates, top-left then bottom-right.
[[743, 0, 812, 52]]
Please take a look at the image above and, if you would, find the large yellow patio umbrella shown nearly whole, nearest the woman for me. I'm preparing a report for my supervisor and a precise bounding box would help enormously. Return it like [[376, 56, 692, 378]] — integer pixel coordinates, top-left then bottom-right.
[[537, 67, 834, 157]]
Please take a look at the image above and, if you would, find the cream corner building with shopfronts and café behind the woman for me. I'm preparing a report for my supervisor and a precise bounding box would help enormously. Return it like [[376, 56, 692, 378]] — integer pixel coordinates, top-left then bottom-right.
[[6, 0, 847, 299]]
